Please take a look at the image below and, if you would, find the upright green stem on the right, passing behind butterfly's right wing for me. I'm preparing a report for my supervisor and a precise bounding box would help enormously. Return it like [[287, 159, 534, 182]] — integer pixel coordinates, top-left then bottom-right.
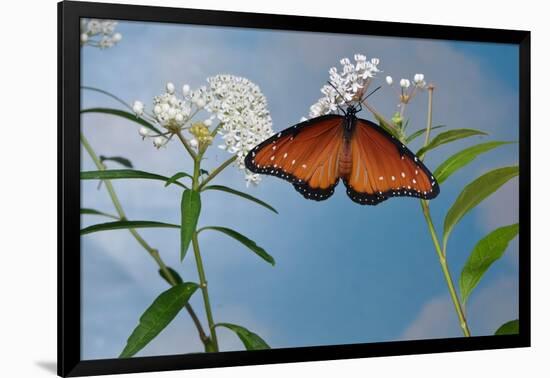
[[420, 85, 471, 337]]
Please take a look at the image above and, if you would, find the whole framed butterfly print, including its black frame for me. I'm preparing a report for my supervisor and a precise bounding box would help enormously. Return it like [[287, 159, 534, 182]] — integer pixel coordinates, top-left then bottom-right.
[[58, 2, 531, 376]]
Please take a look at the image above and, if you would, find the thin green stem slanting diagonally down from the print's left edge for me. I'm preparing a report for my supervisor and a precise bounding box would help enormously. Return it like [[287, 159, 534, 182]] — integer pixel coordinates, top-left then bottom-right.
[[80, 133, 209, 344]]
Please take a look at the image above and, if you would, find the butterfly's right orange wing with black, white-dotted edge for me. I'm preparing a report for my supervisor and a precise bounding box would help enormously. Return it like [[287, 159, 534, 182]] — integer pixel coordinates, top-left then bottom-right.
[[344, 119, 439, 205]]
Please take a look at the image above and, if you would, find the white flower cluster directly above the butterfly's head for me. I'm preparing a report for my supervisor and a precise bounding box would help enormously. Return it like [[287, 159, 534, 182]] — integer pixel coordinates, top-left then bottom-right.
[[309, 54, 380, 118]]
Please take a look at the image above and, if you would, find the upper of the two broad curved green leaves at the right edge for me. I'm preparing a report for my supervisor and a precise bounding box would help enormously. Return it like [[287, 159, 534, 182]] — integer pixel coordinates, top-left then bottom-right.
[[443, 166, 519, 251]]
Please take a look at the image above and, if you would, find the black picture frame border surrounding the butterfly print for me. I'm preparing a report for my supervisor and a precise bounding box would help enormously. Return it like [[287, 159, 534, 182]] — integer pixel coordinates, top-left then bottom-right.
[[58, 1, 531, 377]]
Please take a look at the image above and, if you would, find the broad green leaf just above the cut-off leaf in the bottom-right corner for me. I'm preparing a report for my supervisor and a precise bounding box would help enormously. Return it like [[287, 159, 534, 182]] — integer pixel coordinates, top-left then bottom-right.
[[460, 223, 519, 304]]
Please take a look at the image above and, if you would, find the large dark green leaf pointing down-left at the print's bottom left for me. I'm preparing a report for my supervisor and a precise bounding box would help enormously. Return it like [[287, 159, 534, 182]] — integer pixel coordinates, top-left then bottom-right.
[[119, 282, 198, 358]]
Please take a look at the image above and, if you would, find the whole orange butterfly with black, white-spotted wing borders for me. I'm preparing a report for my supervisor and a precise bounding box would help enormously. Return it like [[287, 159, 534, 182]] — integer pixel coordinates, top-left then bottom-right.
[[245, 106, 439, 205]]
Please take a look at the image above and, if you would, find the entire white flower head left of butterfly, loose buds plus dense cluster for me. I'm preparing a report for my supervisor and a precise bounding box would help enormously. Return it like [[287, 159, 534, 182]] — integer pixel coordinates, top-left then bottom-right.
[[132, 75, 273, 186]]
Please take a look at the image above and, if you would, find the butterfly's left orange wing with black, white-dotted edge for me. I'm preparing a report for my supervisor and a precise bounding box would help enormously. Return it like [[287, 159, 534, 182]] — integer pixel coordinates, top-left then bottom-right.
[[245, 115, 343, 201]]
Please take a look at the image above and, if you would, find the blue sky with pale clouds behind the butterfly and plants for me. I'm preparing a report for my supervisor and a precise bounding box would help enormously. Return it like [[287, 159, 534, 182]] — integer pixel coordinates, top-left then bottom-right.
[[81, 22, 518, 359]]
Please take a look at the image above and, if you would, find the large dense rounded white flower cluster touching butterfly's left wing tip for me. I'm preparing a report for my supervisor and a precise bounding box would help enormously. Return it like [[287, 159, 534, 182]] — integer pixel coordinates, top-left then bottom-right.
[[206, 75, 273, 185]]
